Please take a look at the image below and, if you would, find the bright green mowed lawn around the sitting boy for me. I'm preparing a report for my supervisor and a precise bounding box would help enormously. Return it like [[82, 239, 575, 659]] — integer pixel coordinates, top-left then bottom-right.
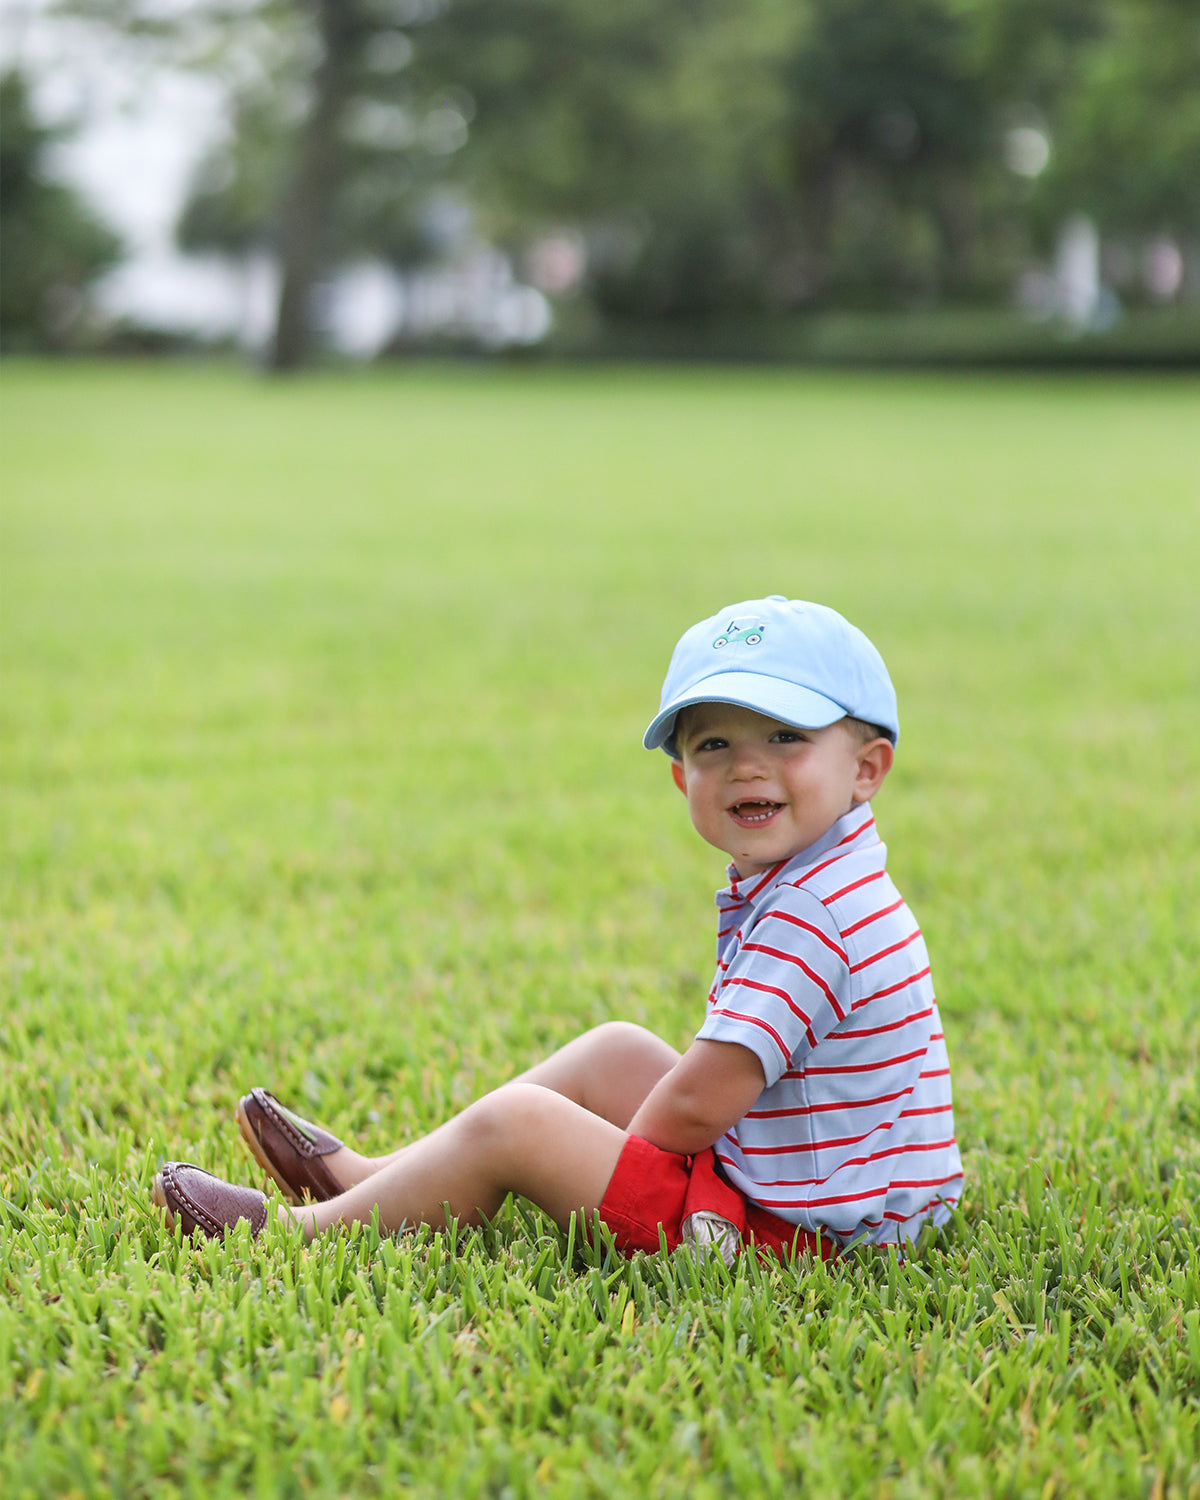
[[0, 363, 1200, 1500]]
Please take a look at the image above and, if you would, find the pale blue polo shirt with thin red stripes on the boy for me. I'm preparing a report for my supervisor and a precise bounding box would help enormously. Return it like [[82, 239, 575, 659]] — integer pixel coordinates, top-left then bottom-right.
[[696, 804, 963, 1245]]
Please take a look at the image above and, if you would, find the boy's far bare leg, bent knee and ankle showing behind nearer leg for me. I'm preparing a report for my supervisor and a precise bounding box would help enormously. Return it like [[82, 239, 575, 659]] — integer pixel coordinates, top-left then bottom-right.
[[313, 1022, 680, 1197]]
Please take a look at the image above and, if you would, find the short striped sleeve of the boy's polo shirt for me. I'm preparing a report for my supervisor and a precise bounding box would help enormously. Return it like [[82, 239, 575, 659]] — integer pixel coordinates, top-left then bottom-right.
[[696, 885, 851, 1088]]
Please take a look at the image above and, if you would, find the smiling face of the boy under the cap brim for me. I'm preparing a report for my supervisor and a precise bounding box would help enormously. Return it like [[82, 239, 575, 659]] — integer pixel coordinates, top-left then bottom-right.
[[672, 704, 893, 879]]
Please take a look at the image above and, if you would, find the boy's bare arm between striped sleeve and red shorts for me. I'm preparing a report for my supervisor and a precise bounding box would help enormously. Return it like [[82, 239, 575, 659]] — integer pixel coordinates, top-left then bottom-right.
[[629, 1041, 767, 1157]]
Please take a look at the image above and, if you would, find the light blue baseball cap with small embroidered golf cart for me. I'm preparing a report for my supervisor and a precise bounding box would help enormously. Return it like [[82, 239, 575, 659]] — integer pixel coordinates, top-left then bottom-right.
[[642, 594, 900, 755]]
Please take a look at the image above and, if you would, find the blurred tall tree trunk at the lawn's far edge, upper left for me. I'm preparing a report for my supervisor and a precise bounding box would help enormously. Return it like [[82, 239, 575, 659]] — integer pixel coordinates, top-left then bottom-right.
[[269, 0, 357, 371]]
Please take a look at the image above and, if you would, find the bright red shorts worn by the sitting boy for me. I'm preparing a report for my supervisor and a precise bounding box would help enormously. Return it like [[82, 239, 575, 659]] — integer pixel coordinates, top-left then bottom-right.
[[600, 1136, 836, 1260]]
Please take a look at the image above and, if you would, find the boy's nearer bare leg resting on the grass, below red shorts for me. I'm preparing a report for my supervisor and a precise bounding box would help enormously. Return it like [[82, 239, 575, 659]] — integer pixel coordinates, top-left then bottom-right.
[[281, 1082, 626, 1239]]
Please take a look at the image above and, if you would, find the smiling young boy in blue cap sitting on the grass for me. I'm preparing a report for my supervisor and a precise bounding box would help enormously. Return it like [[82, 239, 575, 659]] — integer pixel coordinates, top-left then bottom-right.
[[155, 596, 963, 1259]]
